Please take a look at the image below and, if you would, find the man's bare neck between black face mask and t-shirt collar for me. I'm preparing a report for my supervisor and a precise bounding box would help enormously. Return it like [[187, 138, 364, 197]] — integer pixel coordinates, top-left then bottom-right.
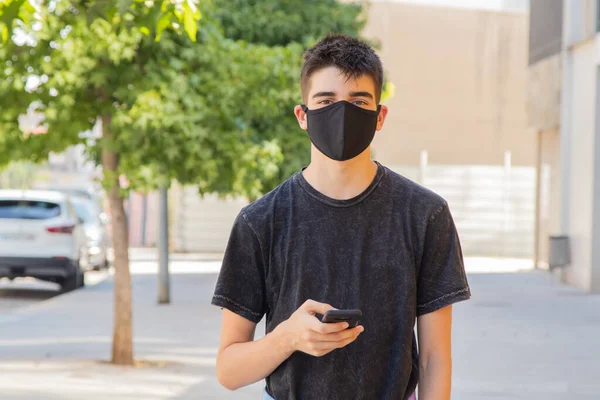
[[303, 152, 377, 200]]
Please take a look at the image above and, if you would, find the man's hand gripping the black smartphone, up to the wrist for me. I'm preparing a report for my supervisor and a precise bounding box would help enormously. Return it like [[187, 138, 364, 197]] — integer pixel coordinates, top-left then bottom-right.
[[275, 300, 364, 357]]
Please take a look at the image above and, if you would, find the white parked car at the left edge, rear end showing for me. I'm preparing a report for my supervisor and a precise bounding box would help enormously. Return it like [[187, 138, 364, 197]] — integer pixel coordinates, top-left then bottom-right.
[[0, 190, 89, 291]]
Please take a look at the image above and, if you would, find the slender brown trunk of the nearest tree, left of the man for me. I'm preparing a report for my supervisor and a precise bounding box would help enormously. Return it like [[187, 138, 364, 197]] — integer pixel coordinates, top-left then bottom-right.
[[102, 116, 133, 365]]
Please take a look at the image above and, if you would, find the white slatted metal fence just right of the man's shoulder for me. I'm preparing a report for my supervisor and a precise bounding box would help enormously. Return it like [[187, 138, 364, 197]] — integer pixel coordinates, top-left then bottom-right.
[[392, 165, 535, 258]]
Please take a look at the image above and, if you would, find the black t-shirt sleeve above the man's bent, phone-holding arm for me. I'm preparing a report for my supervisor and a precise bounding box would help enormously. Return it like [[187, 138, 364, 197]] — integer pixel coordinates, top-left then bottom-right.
[[211, 213, 266, 323]]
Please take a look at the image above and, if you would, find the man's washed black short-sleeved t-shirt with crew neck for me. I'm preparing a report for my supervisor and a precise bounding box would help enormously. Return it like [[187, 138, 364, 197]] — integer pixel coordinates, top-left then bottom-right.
[[212, 164, 470, 400]]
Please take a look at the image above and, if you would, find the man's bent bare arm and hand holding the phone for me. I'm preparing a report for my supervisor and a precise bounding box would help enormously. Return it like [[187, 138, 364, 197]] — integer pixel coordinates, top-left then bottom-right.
[[217, 300, 364, 390]]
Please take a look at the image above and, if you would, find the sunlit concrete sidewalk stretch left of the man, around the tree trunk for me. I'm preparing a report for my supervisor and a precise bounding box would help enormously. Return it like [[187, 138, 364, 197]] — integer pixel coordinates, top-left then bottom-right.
[[0, 262, 263, 400]]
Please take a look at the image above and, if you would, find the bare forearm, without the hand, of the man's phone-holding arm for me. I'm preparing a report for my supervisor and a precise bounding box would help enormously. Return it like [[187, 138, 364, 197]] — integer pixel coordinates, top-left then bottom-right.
[[217, 322, 294, 390]]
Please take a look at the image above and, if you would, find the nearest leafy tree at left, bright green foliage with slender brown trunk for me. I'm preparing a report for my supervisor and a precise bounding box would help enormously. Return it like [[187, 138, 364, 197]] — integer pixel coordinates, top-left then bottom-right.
[[0, 0, 200, 365]]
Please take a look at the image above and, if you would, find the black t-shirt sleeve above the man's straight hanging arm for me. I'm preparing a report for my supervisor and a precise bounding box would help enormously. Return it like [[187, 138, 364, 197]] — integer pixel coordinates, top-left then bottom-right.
[[417, 204, 471, 316]]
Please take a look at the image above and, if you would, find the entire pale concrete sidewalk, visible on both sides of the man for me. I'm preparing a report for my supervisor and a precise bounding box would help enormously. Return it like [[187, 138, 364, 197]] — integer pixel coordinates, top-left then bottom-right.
[[0, 261, 600, 400]]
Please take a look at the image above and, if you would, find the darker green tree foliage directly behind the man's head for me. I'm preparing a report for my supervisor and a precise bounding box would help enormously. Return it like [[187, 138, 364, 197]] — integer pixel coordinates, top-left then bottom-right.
[[213, 0, 367, 189]]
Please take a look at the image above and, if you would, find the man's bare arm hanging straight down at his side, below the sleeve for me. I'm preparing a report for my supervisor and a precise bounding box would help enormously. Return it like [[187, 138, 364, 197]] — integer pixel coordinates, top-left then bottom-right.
[[417, 306, 452, 400]]
